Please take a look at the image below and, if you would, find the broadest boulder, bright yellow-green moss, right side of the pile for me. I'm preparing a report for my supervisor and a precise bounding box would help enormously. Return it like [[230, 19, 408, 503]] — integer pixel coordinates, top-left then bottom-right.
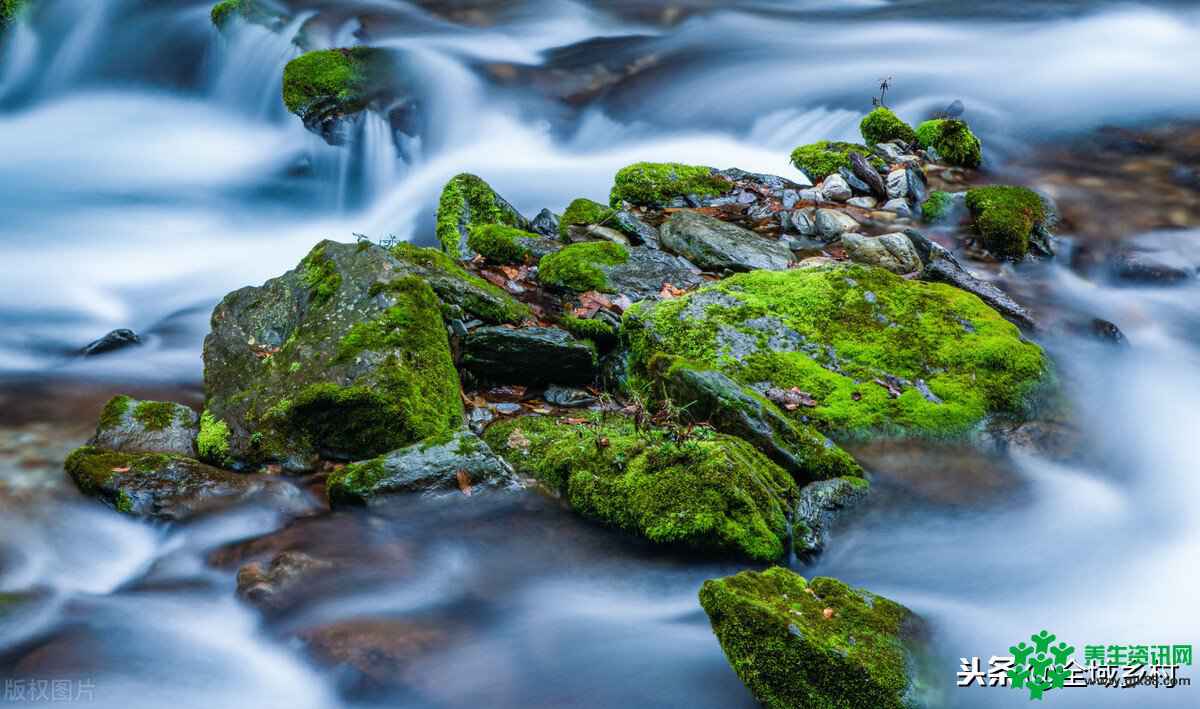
[[622, 265, 1051, 437]]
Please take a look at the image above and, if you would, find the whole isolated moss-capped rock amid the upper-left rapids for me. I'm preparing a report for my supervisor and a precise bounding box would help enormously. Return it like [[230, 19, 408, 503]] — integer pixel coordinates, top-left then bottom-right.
[[283, 47, 395, 145]]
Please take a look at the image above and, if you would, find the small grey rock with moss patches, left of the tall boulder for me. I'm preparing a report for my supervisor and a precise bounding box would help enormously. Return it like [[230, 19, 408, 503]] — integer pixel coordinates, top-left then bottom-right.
[[89, 396, 200, 457]]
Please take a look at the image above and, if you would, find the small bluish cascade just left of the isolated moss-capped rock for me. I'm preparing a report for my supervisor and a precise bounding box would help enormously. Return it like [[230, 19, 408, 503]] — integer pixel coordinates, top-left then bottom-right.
[[209, 12, 314, 120]]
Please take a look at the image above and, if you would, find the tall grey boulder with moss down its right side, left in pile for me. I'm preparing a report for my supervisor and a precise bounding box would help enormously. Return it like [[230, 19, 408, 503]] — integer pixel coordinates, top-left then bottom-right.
[[199, 241, 462, 470]]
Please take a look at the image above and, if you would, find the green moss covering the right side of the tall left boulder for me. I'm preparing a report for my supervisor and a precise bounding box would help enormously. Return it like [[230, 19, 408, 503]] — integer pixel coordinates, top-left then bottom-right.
[[288, 276, 462, 456]]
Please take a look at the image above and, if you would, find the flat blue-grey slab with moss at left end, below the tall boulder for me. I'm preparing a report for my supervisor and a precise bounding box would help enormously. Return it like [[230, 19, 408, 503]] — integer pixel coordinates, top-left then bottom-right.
[[326, 429, 517, 506]]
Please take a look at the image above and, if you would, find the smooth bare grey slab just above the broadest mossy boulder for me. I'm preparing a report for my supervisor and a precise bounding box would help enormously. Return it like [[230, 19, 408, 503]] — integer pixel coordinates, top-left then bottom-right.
[[660, 211, 792, 271]]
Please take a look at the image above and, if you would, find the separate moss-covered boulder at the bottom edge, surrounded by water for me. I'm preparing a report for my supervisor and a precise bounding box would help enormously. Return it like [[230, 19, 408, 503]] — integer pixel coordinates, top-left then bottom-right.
[[700, 567, 926, 709]]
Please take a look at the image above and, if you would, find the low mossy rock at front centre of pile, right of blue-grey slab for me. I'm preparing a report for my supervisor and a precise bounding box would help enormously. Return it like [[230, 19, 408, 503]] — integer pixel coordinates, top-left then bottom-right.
[[484, 415, 798, 561]]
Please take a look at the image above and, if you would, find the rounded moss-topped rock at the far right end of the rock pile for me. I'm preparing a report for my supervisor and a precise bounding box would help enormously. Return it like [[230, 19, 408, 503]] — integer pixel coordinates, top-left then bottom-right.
[[966, 185, 1046, 259]]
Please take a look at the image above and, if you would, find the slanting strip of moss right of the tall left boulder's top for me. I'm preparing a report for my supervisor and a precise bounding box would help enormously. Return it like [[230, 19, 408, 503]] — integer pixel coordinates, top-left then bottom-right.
[[391, 242, 529, 324]]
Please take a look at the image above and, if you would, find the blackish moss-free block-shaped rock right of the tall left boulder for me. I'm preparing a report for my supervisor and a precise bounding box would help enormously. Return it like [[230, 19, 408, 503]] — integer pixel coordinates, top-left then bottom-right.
[[462, 328, 596, 384]]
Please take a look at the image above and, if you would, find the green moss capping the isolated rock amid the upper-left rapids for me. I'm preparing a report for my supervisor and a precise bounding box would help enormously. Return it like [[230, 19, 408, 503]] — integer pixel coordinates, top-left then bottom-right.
[[283, 47, 379, 118]]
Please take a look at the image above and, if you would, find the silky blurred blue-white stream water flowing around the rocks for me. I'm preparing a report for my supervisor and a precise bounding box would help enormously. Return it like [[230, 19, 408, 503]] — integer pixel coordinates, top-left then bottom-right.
[[0, 0, 1200, 708]]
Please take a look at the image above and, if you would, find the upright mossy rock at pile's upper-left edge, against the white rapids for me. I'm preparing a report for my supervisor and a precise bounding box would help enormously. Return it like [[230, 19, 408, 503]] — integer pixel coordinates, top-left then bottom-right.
[[437, 173, 532, 260]]
